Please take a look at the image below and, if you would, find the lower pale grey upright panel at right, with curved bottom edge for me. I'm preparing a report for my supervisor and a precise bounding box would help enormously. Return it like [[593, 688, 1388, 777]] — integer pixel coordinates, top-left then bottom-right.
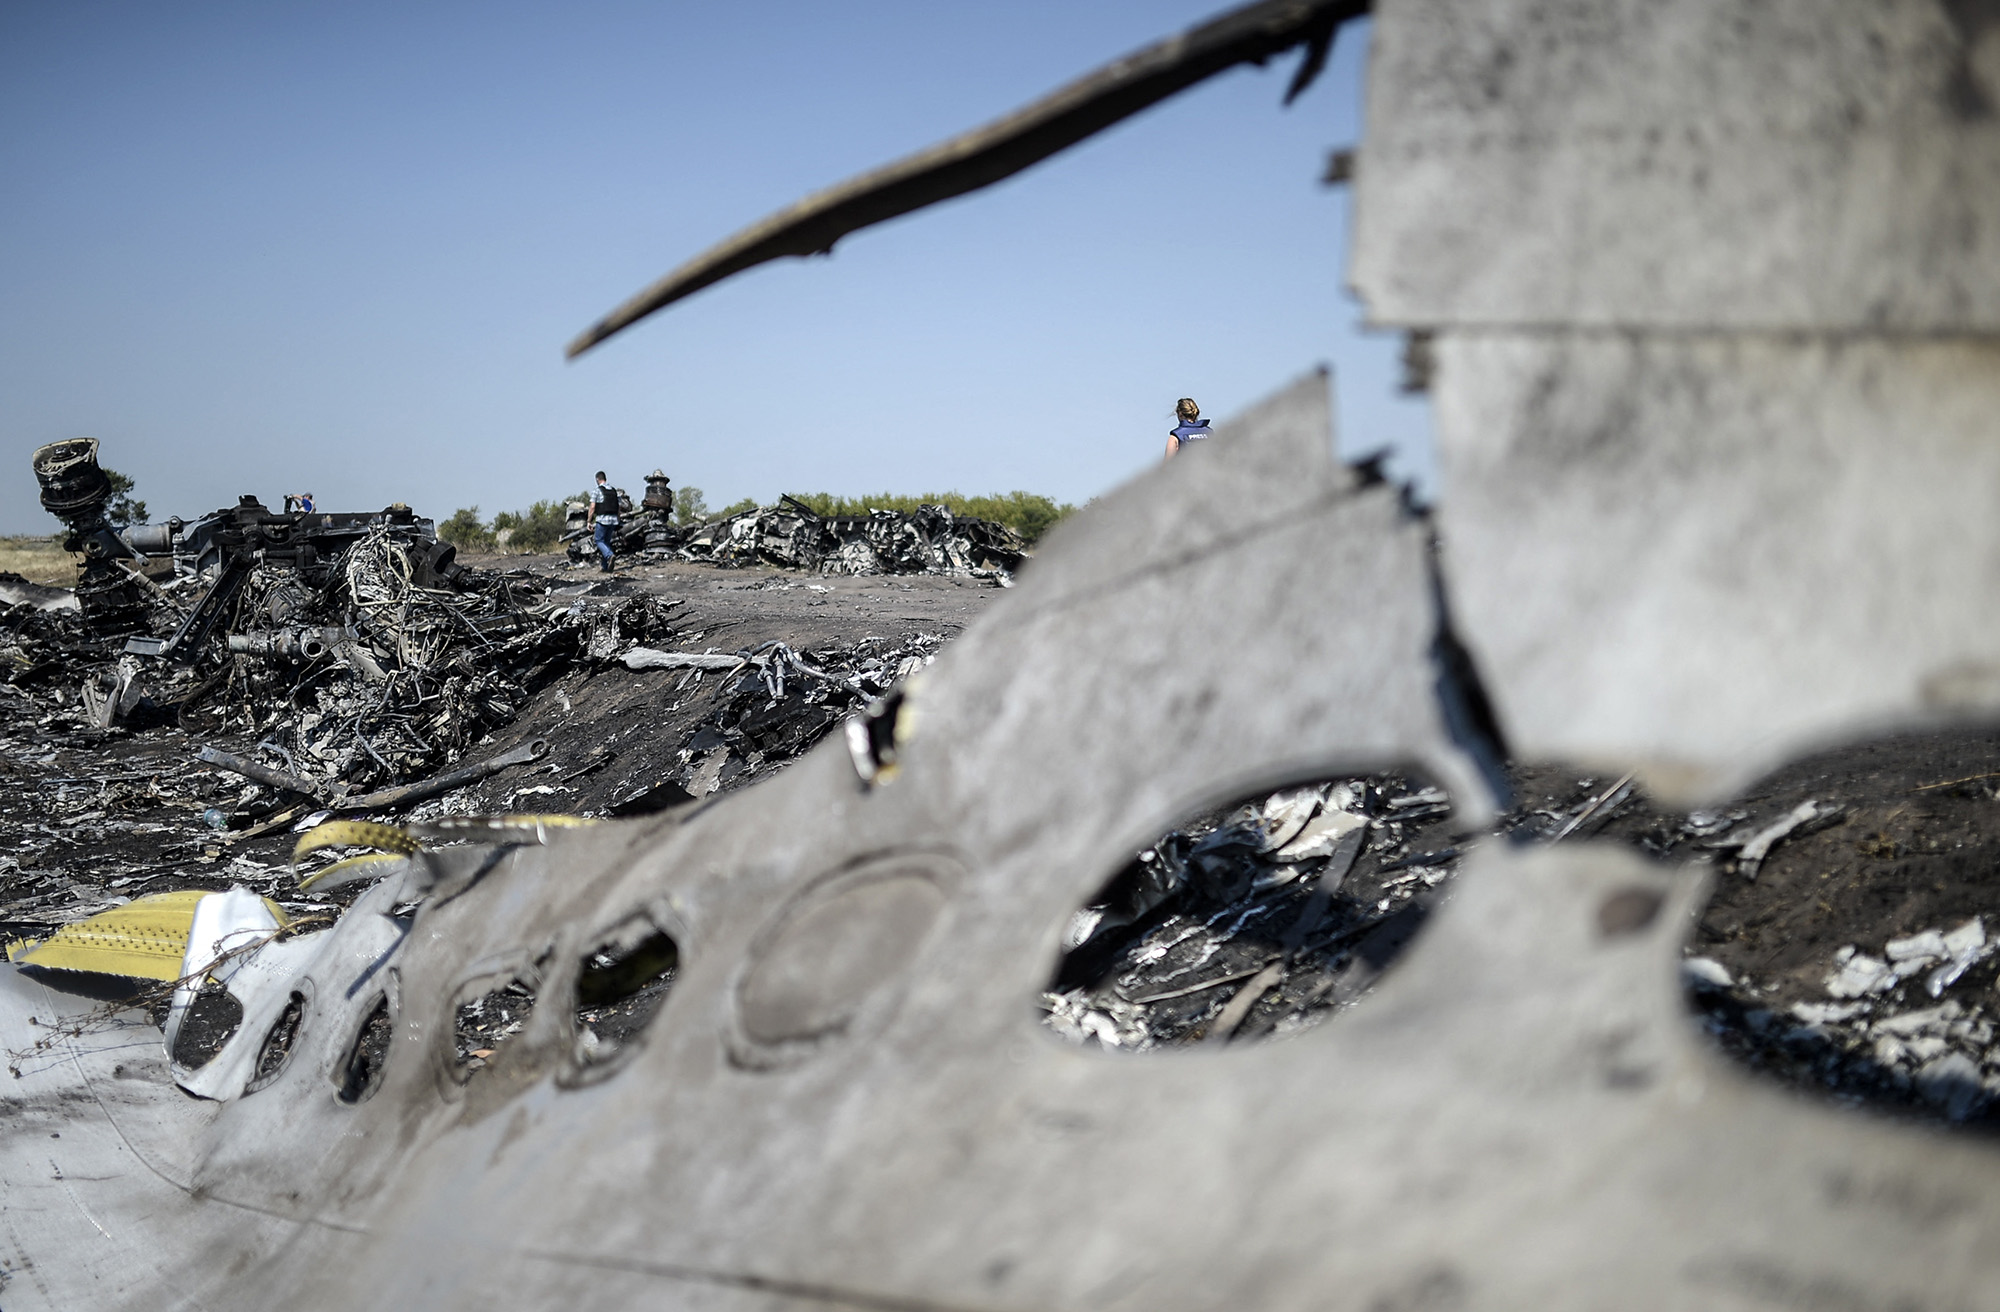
[[1436, 332, 2000, 800]]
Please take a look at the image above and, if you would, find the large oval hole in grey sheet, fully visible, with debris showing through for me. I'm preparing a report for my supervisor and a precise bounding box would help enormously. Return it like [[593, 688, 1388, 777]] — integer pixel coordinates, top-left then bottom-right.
[[1042, 774, 1468, 1052]]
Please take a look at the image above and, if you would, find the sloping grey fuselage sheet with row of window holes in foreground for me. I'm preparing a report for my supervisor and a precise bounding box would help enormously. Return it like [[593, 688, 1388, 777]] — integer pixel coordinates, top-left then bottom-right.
[[0, 378, 2000, 1312]]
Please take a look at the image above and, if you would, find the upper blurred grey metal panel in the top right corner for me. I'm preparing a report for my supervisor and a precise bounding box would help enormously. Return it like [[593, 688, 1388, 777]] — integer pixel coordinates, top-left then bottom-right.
[[1350, 0, 2000, 332]]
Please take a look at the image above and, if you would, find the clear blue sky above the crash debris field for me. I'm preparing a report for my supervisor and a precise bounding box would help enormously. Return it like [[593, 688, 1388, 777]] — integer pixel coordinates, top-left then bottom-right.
[[0, 0, 1428, 532]]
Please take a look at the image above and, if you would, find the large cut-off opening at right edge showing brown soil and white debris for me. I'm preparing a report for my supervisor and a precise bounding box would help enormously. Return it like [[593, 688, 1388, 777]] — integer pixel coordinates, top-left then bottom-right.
[[1654, 730, 2000, 1134]]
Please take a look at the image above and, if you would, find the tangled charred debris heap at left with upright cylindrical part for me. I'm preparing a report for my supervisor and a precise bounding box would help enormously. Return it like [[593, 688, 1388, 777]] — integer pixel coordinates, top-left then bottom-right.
[[21, 440, 576, 802]]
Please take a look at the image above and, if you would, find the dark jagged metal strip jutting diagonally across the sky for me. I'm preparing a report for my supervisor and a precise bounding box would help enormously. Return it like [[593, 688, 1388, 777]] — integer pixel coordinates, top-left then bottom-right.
[[564, 0, 1368, 360]]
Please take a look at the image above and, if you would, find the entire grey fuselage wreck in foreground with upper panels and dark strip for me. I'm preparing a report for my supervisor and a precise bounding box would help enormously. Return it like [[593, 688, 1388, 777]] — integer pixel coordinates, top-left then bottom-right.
[[0, 0, 2000, 1310]]
